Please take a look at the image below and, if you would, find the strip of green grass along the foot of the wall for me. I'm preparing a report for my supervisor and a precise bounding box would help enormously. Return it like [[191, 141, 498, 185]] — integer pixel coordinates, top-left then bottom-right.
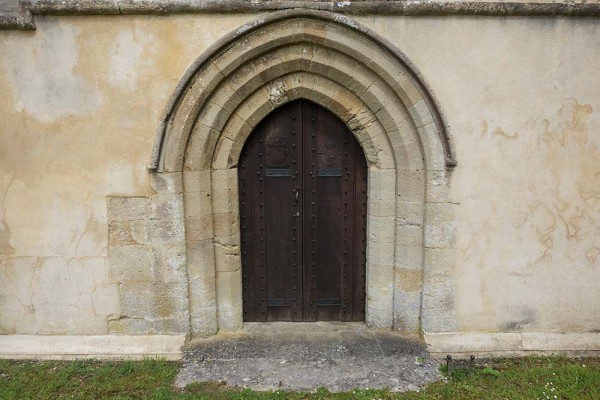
[[0, 358, 600, 400]]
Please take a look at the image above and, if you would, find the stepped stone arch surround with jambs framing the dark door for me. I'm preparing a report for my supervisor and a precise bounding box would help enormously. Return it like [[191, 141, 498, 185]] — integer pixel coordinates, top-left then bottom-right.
[[151, 11, 456, 336]]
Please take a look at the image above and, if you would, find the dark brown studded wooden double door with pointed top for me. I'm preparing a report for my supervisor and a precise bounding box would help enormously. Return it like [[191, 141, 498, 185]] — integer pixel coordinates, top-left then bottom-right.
[[238, 100, 367, 321]]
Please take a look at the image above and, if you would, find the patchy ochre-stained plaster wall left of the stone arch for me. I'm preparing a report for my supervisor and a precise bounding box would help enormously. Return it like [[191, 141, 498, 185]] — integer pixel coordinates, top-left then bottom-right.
[[0, 15, 251, 334]]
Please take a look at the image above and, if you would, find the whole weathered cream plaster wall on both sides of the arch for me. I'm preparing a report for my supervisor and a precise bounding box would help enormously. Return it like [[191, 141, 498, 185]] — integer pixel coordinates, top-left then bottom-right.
[[0, 14, 600, 334]]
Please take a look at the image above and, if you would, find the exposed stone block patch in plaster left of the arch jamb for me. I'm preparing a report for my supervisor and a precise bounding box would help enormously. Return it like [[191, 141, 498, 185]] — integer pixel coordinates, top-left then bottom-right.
[[107, 188, 189, 335]]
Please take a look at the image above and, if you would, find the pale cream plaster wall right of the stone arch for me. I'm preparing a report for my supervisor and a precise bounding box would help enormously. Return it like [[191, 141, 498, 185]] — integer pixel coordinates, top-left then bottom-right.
[[358, 17, 600, 332]]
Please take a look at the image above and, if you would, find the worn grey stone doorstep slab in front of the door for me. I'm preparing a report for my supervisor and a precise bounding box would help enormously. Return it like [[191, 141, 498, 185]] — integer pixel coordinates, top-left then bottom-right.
[[176, 323, 442, 391]]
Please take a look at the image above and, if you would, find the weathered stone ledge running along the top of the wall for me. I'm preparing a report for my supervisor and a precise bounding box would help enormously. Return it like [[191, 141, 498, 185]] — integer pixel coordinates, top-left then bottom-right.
[[0, 0, 600, 30]]
